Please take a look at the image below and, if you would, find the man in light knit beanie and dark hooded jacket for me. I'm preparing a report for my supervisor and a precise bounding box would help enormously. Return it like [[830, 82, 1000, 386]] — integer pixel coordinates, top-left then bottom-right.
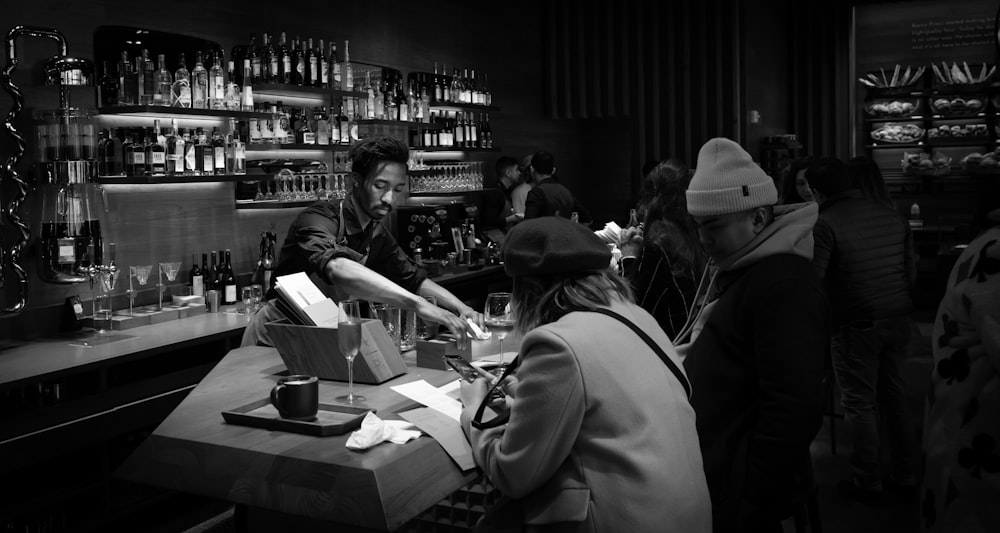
[[675, 138, 830, 532]]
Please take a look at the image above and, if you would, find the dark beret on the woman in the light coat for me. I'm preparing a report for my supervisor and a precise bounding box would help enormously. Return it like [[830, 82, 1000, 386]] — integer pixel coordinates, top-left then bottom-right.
[[502, 217, 611, 276]]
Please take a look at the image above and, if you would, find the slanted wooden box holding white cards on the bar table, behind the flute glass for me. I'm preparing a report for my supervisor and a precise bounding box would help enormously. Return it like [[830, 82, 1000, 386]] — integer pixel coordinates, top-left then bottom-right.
[[267, 319, 406, 385]]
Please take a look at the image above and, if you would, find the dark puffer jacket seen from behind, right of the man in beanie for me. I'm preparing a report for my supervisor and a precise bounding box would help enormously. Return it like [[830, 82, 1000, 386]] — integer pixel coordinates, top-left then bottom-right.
[[813, 190, 915, 324]]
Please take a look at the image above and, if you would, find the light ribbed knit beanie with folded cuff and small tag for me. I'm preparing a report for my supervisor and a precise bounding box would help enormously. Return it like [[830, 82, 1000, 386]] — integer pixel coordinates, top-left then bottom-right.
[[687, 137, 778, 216]]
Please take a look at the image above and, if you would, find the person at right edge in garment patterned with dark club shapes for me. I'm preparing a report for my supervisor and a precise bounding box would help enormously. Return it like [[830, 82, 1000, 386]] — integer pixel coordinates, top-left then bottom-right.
[[920, 180, 1000, 533]]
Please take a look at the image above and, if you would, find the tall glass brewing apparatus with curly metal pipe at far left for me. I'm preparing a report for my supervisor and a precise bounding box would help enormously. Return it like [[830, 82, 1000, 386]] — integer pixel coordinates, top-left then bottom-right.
[[0, 26, 103, 314]]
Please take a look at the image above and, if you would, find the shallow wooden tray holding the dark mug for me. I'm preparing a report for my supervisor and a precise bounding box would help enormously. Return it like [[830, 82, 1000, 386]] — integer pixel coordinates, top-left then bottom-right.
[[222, 398, 375, 437]]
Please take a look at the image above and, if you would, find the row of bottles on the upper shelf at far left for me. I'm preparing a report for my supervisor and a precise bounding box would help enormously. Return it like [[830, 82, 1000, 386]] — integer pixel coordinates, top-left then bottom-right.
[[98, 49, 253, 111]]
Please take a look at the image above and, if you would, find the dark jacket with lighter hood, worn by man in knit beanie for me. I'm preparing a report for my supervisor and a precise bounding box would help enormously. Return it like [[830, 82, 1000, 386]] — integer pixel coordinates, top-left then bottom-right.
[[684, 204, 830, 532]]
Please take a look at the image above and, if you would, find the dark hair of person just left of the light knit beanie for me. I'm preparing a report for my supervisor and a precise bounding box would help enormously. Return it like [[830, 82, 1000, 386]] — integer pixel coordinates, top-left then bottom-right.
[[637, 159, 705, 275]]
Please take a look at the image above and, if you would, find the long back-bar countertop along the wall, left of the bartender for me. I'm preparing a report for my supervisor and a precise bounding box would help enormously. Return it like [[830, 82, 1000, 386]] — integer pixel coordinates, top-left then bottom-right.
[[0, 312, 247, 387]]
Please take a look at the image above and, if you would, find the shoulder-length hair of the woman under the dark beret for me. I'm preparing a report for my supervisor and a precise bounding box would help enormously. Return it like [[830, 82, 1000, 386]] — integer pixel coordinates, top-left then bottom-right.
[[511, 269, 633, 334]]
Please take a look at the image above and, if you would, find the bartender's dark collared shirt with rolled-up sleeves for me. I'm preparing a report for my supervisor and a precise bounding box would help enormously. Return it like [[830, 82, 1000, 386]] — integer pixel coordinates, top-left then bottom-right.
[[269, 196, 427, 299]]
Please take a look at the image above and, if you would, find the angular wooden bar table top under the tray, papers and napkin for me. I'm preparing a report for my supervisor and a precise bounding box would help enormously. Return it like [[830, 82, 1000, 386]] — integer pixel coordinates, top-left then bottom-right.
[[115, 339, 517, 531]]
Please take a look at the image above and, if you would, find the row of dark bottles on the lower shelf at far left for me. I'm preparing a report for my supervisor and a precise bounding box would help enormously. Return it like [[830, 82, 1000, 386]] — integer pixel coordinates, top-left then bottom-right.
[[97, 119, 246, 176]]
